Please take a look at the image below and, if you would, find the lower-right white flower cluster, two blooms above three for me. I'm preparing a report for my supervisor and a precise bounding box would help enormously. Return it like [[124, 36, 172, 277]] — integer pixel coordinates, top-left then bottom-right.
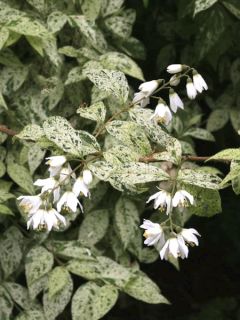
[[140, 190, 200, 260]]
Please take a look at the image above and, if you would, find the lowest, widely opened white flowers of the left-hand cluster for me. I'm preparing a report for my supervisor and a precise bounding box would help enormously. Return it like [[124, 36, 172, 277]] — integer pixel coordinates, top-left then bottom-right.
[[27, 208, 66, 231]]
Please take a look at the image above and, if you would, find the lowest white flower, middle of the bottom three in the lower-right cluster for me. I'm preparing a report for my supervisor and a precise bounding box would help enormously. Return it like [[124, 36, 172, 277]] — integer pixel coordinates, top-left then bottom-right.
[[160, 235, 188, 260]]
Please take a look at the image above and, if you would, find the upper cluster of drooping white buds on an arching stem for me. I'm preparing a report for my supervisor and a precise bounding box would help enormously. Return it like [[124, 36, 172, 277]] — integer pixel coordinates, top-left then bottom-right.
[[133, 64, 208, 125]]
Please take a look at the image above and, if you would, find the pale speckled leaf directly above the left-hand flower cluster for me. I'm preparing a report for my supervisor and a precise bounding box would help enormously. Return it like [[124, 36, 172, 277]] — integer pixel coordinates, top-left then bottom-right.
[[43, 116, 99, 156]]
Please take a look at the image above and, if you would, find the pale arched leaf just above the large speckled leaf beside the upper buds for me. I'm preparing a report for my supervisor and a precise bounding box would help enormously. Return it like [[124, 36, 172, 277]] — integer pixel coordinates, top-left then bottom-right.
[[99, 52, 144, 81]]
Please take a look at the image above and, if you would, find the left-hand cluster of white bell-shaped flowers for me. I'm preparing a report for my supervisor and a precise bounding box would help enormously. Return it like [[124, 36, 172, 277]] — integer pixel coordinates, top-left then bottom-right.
[[18, 156, 92, 231]]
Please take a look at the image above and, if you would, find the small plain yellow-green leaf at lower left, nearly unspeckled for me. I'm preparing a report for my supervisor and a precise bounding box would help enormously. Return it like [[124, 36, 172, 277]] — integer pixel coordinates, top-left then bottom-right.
[[48, 267, 69, 299]]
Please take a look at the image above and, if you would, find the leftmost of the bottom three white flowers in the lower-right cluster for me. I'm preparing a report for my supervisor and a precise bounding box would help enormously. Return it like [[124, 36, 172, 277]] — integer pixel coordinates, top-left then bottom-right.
[[140, 219, 165, 249]]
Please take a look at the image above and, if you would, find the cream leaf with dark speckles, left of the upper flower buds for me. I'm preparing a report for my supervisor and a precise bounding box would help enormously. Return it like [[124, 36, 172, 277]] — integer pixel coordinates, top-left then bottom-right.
[[84, 69, 129, 103]]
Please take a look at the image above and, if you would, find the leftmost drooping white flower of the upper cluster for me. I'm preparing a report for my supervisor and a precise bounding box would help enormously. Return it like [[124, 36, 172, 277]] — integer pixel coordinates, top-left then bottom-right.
[[133, 80, 159, 107]]
